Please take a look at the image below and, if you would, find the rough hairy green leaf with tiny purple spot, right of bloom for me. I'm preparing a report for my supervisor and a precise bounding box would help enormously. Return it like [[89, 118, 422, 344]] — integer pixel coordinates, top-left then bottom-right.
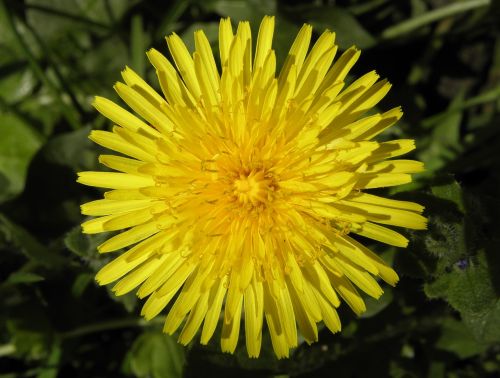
[[424, 181, 500, 343]]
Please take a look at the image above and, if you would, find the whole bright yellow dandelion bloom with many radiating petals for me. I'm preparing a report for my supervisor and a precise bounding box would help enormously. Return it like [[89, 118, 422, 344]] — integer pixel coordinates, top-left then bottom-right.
[[78, 17, 426, 358]]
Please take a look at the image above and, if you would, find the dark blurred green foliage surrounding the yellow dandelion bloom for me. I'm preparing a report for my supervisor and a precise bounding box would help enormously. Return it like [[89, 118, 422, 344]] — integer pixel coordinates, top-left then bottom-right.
[[0, 0, 500, 378]]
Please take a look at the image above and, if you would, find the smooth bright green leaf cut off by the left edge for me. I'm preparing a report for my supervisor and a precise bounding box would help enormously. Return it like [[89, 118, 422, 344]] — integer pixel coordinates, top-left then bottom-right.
[[0, 113, 42, 203]]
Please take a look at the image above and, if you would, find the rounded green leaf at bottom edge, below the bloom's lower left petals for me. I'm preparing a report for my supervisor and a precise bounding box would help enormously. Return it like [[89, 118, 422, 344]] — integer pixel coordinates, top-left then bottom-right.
[[125, 331, 185, 378]]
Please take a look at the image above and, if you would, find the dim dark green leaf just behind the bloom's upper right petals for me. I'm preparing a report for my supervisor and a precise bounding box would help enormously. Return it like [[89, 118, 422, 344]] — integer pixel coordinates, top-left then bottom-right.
[[301, 6, 376, 49]]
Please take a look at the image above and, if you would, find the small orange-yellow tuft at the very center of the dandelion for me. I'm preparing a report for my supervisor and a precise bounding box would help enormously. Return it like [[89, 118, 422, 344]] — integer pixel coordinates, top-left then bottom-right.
[[234, 170, 271, 206]]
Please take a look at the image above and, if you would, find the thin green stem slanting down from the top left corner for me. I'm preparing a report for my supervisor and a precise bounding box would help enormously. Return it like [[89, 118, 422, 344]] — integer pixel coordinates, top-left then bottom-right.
[[0, 0, 79, 129]]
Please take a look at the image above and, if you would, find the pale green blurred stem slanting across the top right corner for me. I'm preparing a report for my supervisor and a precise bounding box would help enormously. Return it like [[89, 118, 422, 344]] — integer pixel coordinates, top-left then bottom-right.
[[381, 0, 490, 39]]
